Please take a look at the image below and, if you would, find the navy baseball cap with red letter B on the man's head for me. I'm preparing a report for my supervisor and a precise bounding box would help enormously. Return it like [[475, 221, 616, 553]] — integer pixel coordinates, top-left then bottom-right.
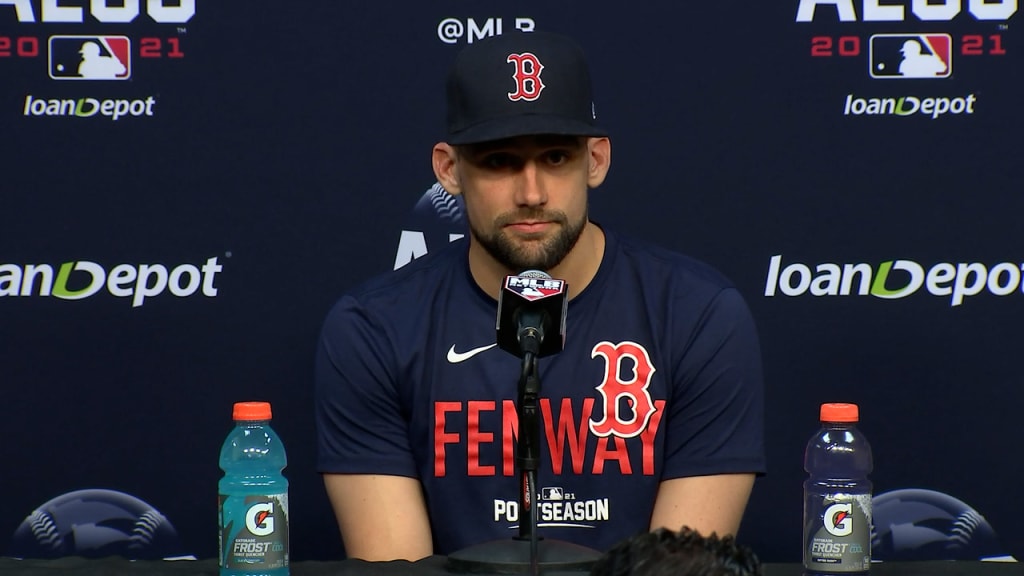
[[447, 32, 608, 145]]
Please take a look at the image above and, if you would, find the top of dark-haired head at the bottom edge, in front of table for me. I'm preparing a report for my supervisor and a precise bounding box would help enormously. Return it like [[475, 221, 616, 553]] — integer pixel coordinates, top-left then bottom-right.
[[590, 527, 763, 576]]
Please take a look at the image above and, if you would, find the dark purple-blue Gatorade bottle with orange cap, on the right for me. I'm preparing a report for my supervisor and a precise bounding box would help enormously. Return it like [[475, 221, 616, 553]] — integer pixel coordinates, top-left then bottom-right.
[[804, 404, 872, 574]]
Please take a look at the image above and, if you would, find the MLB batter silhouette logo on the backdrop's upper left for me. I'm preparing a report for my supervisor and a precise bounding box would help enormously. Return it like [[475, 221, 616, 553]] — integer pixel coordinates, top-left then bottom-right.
[[49, 36, 131, 80]]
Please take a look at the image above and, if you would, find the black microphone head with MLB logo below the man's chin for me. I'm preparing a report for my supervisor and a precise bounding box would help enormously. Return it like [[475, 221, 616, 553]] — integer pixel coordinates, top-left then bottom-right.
[[496, 270, 568, 358]]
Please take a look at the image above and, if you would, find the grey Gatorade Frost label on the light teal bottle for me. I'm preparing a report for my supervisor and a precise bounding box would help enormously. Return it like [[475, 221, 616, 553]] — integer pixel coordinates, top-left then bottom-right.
[[220, 494, 288, 570]]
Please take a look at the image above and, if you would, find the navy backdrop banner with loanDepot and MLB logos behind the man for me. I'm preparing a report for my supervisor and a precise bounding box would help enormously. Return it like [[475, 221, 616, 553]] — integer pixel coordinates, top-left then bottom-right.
[[0, 0, 1024, 562]]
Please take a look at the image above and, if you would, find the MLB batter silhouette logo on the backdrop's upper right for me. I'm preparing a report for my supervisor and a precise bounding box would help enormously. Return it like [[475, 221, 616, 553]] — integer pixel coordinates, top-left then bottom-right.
[[870, 34, 953, 79]]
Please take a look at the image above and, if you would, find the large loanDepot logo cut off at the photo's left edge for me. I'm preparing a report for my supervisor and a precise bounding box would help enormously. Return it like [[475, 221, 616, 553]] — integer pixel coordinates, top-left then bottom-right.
[[0, 257, 223, 307]]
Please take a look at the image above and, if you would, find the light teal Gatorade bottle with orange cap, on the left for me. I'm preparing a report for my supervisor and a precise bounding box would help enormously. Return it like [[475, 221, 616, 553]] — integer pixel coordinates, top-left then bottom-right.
[[219, 402, 289, 576]]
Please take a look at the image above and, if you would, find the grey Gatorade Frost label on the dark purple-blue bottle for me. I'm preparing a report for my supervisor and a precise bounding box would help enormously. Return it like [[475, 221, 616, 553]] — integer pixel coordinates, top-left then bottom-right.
[[804, 493, 871, 573]]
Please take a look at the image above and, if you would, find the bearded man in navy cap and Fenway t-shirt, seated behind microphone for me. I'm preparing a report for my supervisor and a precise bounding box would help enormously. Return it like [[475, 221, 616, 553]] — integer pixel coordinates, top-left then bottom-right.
[[315, 32, 765, 561]]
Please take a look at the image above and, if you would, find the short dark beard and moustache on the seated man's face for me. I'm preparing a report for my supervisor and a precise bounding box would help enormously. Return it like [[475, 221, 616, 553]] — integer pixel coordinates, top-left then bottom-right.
[[469, 209, 587, 273]]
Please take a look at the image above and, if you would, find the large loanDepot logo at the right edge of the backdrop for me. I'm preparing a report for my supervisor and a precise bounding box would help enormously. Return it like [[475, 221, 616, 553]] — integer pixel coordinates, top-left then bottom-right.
[[765, 255, 1024, 306]]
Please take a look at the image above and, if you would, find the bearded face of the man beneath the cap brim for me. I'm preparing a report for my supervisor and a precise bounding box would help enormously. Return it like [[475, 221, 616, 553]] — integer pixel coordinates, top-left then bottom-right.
[[458, 135, 589, 272]]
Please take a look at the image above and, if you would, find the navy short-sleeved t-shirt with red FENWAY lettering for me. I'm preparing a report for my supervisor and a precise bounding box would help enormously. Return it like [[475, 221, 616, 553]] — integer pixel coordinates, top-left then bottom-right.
[[315, 226, 765, 554]]
